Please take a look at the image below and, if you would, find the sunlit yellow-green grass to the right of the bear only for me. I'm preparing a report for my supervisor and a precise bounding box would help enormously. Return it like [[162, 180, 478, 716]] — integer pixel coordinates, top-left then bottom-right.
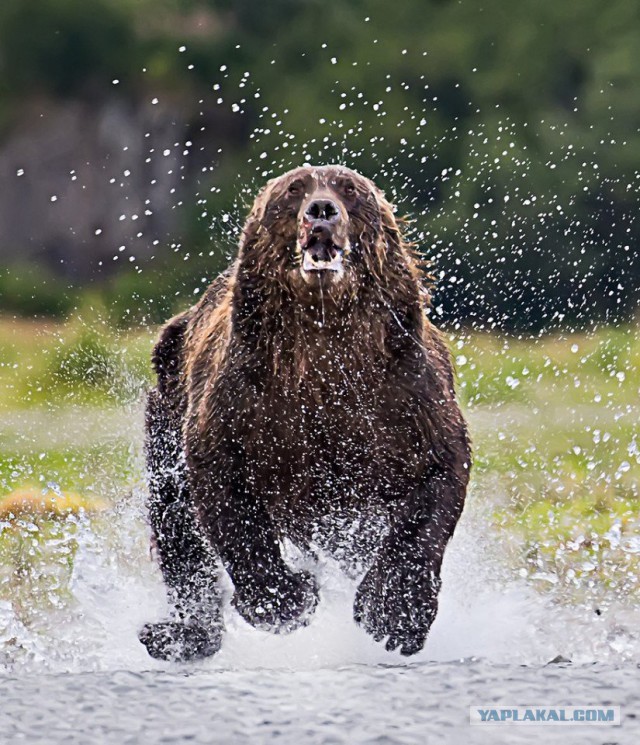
[[457, 328, 640, 605]]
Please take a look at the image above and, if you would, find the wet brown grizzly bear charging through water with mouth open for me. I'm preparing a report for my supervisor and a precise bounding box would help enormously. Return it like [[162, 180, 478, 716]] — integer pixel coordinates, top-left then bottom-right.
[[140, 166, 471, 660]]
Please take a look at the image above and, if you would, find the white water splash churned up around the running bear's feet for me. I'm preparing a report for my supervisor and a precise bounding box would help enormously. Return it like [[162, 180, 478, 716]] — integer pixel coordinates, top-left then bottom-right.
[[0, 476, 640, 673]]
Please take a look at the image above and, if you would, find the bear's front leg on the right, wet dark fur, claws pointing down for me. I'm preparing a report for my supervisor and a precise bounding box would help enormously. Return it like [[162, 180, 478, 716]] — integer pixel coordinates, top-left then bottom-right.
[[354, 464, 468, 655]]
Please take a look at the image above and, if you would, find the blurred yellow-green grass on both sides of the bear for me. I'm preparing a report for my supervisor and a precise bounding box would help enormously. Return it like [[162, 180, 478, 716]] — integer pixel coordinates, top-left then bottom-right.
[[0, 319, 640, 620]]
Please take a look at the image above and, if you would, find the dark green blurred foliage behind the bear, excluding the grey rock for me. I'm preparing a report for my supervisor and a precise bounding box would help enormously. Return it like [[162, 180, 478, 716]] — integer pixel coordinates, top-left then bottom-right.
[[0, 0, 640, 328]]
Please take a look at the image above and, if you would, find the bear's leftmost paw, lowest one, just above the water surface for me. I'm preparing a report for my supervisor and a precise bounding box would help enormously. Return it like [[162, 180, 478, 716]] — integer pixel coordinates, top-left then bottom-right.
[[138, 621, 222, 662]]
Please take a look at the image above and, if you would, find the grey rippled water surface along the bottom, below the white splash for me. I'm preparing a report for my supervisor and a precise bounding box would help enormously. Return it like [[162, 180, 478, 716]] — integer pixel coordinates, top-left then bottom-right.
[[0, 661, 640, 744]]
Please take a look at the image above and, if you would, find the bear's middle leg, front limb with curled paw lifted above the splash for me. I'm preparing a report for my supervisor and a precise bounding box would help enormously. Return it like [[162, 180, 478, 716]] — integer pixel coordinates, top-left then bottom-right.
[[194, 481, 318, 633]]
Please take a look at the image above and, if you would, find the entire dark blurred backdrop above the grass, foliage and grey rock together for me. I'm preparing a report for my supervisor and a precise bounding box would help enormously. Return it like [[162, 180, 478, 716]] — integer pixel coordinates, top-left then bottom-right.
[[0, 0, 640, 329]]
